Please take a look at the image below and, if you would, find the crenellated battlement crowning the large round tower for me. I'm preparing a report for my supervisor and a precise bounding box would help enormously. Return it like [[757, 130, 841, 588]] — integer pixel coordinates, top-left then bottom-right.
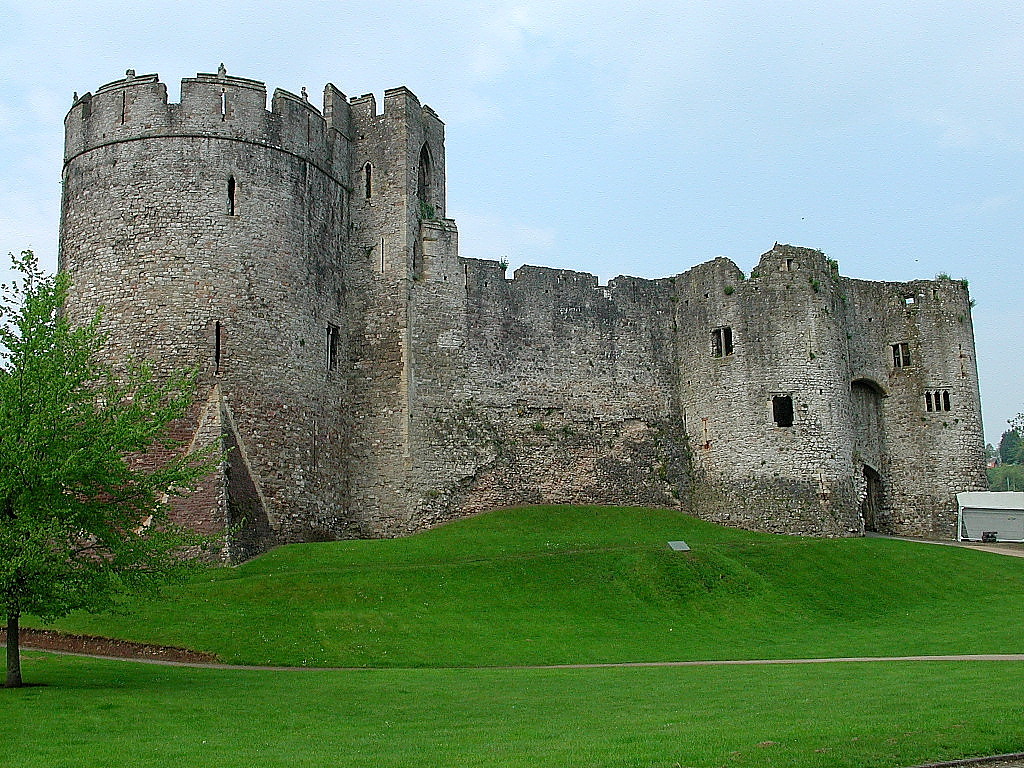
[[65, 67, 350, 178]]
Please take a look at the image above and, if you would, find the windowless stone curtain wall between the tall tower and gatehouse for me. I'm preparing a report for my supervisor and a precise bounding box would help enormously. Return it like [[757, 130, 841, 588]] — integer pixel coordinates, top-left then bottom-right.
[[399, 252, 688, 522]]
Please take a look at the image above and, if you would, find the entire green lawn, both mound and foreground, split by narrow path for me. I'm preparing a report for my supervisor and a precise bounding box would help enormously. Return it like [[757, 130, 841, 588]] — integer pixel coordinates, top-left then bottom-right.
[[8, 507, 1024, 768]]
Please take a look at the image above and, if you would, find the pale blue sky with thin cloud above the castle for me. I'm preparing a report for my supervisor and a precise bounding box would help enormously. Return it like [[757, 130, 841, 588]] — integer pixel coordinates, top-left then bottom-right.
[[0, 0, 1024, 443]]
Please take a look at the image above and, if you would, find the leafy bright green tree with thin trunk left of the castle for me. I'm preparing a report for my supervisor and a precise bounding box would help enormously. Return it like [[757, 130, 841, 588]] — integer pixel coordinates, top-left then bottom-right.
[[0, 251, 212, 687]]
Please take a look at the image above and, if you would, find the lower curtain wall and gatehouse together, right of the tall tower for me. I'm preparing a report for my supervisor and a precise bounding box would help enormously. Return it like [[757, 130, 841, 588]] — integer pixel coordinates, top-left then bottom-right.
[[397, 240, 981, 537]]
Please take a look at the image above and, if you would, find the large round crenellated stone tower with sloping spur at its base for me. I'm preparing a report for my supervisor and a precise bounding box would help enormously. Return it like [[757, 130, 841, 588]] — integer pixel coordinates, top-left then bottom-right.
[[60, 73, 349, 549]]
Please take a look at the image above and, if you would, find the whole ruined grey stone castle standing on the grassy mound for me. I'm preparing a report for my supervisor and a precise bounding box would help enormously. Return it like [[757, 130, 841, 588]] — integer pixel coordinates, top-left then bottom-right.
[[59, 67, 984, 559]]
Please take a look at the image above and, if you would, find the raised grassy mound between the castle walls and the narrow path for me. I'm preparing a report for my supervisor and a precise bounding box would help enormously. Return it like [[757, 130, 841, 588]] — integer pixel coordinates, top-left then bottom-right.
[[25, 507, 1024, 667]]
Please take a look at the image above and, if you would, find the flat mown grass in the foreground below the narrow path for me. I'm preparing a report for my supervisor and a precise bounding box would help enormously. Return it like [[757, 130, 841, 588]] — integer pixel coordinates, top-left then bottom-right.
[[0, 653, 1024, 768]]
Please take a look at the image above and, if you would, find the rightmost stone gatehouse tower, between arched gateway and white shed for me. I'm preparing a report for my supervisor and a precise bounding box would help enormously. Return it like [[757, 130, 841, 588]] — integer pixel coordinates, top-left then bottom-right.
[[843, 279, 986, 539]]
